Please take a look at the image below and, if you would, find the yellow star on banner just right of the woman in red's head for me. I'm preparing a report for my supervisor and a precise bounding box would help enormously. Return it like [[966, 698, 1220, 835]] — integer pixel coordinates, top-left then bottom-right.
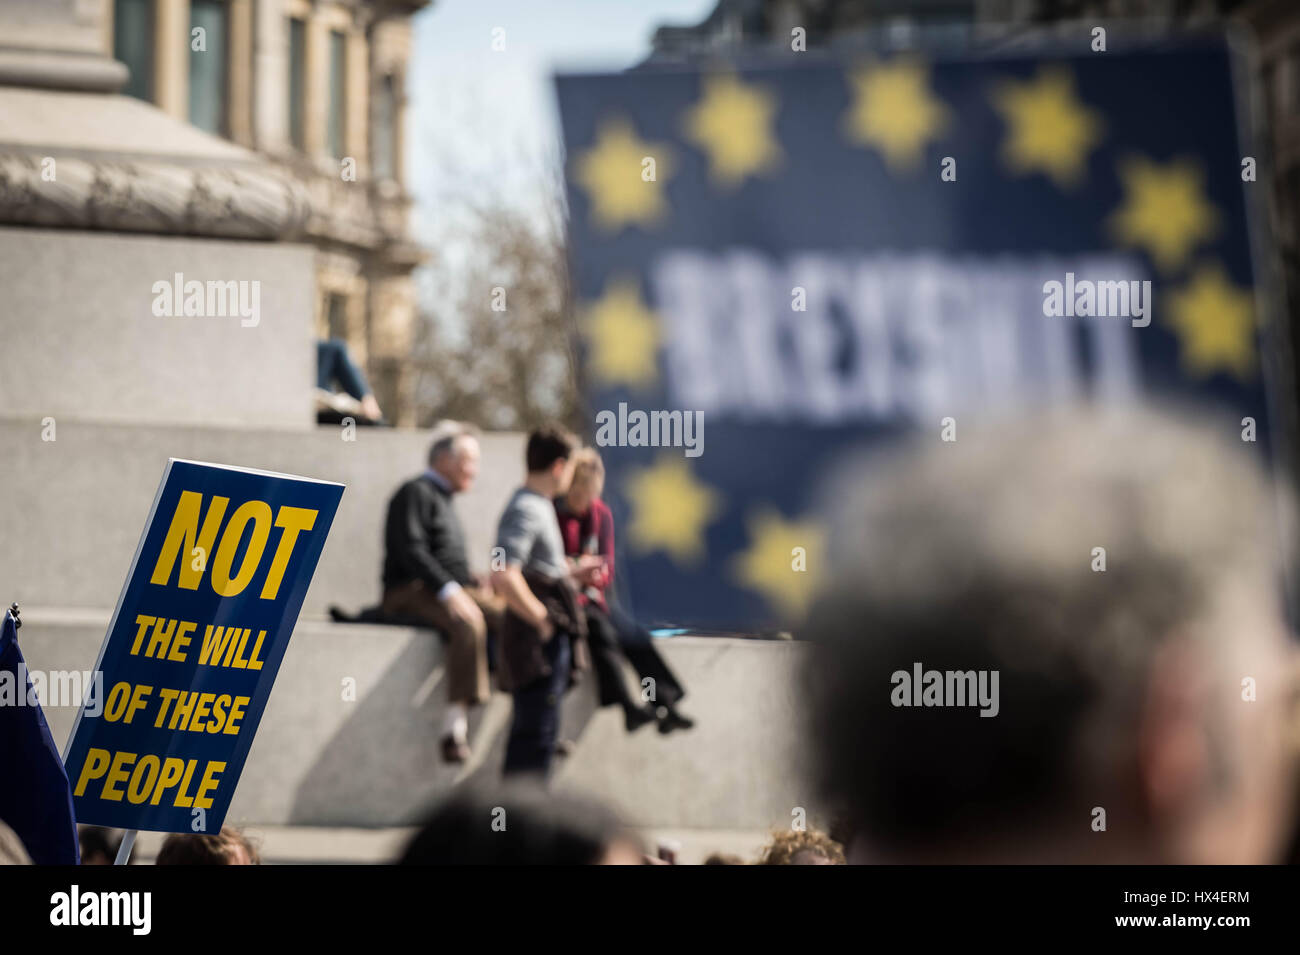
[[624, 457, 720, 564]]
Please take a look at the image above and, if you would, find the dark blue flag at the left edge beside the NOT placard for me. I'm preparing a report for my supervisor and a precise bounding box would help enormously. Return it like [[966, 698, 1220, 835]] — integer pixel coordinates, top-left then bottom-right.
[[0, 612, 81, 865]]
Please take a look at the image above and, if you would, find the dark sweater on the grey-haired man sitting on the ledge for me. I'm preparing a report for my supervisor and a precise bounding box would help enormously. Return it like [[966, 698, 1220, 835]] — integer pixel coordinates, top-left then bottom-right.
[[384, 474, 473, 592]]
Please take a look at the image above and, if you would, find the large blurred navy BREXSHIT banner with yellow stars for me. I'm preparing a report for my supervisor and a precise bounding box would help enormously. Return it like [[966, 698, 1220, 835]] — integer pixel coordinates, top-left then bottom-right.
[[556, 42, 1269, 629]]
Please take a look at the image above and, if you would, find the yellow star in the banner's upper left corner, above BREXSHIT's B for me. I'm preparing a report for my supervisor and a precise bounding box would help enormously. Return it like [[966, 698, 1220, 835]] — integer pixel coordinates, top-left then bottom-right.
[[575, 118, 672, 231]]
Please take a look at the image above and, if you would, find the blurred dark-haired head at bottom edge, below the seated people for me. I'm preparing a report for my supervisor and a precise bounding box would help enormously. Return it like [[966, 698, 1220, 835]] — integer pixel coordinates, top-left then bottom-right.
[[398, 786, 645, 865]]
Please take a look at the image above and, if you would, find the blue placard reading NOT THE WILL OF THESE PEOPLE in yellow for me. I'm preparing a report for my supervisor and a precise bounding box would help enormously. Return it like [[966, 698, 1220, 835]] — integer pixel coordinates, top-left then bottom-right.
[[65, 459, 343, 833]]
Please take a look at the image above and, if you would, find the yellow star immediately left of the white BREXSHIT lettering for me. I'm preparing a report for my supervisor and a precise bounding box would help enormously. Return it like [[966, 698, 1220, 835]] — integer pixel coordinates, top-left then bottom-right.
[[582, 278, 659, 387]]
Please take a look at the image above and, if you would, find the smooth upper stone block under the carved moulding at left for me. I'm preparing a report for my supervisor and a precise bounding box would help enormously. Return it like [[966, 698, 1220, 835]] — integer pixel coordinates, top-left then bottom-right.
[[0, 227, 316, 430]]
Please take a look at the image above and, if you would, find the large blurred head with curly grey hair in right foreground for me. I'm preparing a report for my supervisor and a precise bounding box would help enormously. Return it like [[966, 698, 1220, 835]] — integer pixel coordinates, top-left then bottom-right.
[[809, 411, 1295, 863]]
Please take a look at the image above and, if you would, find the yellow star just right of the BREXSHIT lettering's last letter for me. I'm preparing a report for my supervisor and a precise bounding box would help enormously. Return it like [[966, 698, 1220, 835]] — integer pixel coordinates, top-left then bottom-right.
[[1169, 265, 1255, 381]]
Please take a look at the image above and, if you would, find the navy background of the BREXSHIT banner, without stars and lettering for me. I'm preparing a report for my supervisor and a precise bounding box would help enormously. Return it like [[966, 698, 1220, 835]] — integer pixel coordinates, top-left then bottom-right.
[[556, 42, 1271, 630]]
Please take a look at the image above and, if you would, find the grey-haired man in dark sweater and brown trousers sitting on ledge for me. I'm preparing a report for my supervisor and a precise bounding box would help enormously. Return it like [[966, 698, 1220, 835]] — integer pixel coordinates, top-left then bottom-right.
[[384, 425, 502, 763]]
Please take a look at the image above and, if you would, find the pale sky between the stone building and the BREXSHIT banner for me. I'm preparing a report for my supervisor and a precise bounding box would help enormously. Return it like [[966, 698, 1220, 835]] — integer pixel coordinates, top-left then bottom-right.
[[407, 0, 716, 247]]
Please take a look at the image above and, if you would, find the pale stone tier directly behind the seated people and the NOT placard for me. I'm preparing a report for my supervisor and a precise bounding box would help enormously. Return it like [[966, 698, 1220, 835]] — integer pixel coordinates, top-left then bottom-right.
[[0, 418, 524, 616]]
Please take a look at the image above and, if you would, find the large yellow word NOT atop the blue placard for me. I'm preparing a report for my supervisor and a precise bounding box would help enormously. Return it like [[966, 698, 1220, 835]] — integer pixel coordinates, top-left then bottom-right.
[[150, 491, 317, 600]]
